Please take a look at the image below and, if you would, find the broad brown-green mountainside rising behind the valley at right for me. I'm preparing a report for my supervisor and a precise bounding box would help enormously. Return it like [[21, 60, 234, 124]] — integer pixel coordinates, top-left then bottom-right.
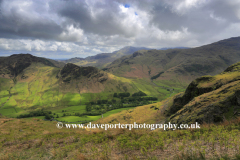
[[103, 37, 240, 87]]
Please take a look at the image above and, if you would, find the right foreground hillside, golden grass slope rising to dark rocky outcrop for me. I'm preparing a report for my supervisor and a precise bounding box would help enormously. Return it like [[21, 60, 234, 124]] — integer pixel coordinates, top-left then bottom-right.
[[96, 59, 240, 128]]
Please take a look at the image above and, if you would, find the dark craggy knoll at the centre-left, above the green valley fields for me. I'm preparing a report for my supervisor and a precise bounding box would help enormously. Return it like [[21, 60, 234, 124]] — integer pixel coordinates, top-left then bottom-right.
[[56, 63, 132, 94]]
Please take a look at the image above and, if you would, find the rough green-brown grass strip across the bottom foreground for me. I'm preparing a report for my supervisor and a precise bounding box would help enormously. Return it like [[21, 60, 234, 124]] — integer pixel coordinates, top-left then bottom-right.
[[0, 117, 240, 160]]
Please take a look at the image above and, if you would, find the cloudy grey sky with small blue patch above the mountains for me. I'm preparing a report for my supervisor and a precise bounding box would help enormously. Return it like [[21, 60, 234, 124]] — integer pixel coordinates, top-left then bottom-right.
[[0, 0, 240, 59]]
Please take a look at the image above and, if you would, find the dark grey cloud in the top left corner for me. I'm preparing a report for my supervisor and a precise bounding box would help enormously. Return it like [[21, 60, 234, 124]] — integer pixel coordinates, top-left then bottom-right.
[[0, 1, 63, 39]]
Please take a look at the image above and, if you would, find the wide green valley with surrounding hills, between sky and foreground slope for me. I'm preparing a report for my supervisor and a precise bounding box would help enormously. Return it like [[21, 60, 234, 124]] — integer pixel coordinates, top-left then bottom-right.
[[0, 37, 240, 122]]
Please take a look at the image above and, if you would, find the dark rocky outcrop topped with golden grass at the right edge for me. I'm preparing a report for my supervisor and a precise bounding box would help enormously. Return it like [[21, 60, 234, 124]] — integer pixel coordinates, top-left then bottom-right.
[[165, 62, 240, 124]]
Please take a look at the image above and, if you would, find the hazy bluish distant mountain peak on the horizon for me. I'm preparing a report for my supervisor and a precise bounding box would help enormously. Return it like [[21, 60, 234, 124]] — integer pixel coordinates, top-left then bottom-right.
[[63, 46, 149, 68]]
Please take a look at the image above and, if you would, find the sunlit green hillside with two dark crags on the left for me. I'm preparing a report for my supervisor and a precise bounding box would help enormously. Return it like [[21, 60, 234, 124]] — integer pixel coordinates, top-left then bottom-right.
[[0, 54, 166, 121]]
